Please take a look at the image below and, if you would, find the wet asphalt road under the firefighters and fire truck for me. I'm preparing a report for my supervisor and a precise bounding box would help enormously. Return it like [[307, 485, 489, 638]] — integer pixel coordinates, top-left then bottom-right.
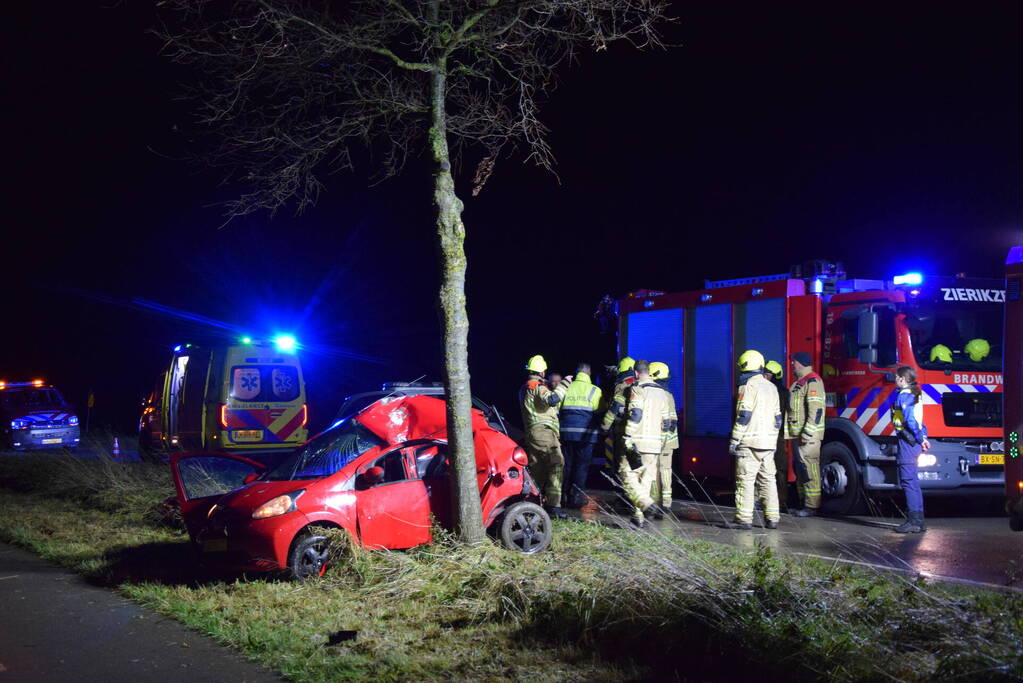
[[569, 492, 1023, 592]]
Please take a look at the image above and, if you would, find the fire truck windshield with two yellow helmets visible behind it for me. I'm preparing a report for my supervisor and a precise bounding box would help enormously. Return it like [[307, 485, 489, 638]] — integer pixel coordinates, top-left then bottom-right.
[[905, 305, 1003, 371]]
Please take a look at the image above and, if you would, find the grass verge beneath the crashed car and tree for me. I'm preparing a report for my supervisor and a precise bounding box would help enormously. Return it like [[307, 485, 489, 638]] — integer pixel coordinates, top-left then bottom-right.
[[0, 456, 1023, 681]]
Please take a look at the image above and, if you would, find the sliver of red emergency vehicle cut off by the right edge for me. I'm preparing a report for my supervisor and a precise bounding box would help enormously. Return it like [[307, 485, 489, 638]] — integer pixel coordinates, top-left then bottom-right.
[[1003, 245, 1023, 532]]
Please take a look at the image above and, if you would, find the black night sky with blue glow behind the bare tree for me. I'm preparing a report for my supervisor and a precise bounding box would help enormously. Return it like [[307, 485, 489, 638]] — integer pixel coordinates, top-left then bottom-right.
[[0, 0, 1023, 429]]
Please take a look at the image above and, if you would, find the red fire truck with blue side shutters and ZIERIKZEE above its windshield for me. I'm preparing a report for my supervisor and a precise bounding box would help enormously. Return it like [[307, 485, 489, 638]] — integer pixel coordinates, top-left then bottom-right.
[[618, 262, 1006, 514]]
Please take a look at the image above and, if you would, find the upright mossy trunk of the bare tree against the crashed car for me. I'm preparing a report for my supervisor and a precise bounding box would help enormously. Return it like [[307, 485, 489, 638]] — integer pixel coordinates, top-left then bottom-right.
[[430, 59, 486, 545]]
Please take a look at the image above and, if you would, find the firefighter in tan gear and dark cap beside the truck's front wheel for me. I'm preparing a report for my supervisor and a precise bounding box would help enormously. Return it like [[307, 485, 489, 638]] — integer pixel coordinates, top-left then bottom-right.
[[785, 351, 825, 517]]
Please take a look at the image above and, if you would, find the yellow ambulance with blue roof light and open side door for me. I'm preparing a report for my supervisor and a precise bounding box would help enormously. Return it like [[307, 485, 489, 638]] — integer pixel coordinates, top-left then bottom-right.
[[139, 335, 309, 456]]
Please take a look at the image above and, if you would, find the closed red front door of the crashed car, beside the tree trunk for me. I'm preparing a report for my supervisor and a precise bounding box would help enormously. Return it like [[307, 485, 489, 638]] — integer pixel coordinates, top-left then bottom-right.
[[355, 446, 433, 548]]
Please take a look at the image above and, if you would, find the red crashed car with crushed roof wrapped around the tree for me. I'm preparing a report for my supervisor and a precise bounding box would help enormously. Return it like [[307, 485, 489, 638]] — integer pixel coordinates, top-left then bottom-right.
[[171, 396, 551, 579]]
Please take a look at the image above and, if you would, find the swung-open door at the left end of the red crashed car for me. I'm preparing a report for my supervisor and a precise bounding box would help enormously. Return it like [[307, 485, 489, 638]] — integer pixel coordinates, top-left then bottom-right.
[[170, 453, 266, 541]]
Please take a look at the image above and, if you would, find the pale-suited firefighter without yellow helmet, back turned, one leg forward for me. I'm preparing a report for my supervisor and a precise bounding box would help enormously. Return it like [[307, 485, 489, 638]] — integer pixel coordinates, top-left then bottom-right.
[[615, 360, 675, 529]]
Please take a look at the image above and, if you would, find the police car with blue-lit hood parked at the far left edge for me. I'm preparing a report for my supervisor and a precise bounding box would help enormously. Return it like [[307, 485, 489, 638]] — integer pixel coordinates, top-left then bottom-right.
[[0, 379, 81, 451]]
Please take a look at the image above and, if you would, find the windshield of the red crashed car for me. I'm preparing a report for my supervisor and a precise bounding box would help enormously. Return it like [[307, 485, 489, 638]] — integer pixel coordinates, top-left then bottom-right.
[[261, 419, 386, 482]]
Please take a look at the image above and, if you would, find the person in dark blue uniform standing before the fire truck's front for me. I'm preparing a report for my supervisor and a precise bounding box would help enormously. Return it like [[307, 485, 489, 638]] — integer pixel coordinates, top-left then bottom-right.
[[892, 365, 931, 534]]
